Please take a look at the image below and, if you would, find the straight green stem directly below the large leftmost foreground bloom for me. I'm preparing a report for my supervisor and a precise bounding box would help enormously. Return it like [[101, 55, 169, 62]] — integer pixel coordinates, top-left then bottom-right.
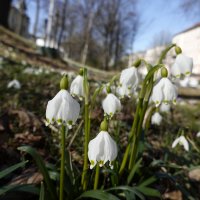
[[59, 125, 66, 200]]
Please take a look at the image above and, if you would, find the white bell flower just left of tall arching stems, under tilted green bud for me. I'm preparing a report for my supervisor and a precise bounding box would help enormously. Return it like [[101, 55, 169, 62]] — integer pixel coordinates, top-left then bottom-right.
[[120, 67, 139, 89]]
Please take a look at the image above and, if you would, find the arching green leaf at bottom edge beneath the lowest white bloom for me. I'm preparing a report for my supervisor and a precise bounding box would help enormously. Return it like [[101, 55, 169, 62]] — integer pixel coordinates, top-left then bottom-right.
[[77, 190, 120, 200]]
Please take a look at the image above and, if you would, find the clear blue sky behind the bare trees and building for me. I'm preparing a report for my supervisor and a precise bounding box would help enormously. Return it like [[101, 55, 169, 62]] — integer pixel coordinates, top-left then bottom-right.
[[14, 0, 200, 52]]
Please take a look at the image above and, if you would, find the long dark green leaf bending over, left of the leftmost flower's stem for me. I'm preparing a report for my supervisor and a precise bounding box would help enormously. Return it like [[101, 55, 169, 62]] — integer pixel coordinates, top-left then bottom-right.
[[18, 146, 57, 200]]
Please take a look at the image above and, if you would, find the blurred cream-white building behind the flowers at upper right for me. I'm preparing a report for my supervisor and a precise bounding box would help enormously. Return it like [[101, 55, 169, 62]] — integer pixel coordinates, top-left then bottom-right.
[[132, 23, 200, 77]]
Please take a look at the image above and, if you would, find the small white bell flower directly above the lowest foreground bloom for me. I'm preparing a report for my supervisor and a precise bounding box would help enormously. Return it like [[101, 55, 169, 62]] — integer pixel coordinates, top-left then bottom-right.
[[102, 93, 121, 117]]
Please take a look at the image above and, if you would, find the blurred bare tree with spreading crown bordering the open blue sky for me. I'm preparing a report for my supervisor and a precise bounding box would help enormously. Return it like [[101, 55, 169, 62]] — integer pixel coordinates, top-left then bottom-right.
[[93, 0, 137, 69]]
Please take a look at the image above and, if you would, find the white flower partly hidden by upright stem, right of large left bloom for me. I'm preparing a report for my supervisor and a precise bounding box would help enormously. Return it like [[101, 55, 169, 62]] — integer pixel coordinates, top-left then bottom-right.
[[70, 75, 84, 100]]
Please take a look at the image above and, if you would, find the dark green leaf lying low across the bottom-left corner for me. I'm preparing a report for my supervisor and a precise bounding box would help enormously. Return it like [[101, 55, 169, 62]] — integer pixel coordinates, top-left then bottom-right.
[[0, 185, 39, 195]]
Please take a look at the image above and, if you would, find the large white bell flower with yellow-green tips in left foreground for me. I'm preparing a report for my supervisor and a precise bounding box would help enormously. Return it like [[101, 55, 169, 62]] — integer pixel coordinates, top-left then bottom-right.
[[46, 90, 80, 128]]
